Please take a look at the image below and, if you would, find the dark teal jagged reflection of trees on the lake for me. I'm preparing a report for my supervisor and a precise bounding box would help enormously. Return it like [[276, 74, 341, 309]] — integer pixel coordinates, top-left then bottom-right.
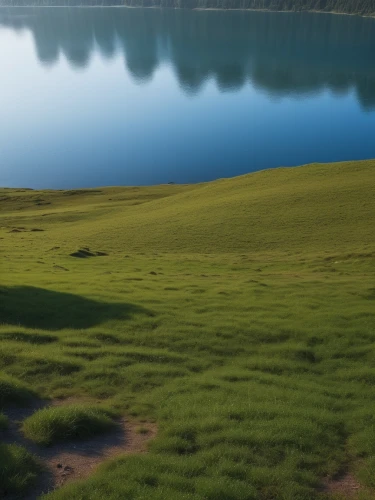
[[0, 8, 375, 108]]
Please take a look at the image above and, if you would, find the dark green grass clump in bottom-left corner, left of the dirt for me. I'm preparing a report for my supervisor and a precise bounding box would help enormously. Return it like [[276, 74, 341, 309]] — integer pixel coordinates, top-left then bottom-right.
[[0, 443, 41, 498]]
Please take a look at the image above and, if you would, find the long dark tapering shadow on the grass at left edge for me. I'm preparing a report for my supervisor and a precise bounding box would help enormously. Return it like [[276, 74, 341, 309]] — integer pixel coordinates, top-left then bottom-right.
[[0, 286, 153, 330]]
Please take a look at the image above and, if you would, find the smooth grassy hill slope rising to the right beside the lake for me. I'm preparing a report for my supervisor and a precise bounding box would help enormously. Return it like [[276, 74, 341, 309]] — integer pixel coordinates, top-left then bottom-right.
[[74, 162, 375, 253]]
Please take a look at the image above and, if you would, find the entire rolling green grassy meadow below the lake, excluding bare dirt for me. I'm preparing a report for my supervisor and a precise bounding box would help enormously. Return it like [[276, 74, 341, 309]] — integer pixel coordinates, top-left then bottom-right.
[[0, 160, 375, 500]]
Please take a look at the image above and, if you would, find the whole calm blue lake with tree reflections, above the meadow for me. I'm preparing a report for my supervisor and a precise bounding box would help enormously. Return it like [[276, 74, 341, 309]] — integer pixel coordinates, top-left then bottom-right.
[[0, 8, 375, 189]]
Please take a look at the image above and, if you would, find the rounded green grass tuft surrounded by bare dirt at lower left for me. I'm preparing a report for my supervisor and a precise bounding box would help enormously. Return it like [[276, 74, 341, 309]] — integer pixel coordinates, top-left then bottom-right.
[[22, 405, 115, 446]]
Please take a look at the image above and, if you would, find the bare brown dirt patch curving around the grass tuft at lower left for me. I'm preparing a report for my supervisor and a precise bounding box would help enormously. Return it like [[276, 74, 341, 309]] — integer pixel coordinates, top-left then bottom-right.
[[0, 399, 157, 500]]
